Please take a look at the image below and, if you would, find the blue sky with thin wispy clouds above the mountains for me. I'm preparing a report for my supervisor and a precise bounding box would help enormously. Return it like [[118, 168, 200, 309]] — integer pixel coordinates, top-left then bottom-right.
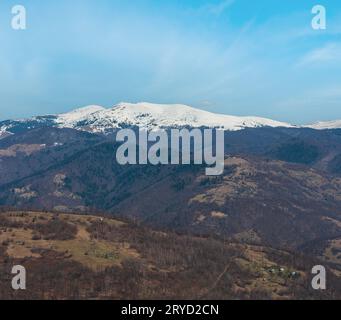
[[0, 0, 341, 124]]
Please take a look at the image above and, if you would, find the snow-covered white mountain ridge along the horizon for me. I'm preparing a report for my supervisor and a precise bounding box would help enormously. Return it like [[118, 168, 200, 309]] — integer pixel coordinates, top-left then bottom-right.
[[0, 102, 341, 137]]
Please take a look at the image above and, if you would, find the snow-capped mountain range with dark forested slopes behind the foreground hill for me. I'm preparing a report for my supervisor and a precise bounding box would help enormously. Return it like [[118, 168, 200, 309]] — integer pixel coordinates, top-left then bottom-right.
[[0, 103, 341, 298]]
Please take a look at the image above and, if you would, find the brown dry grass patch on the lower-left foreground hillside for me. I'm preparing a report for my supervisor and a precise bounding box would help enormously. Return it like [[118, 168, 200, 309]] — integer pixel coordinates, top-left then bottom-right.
[[0, 213, 139, 271]]
